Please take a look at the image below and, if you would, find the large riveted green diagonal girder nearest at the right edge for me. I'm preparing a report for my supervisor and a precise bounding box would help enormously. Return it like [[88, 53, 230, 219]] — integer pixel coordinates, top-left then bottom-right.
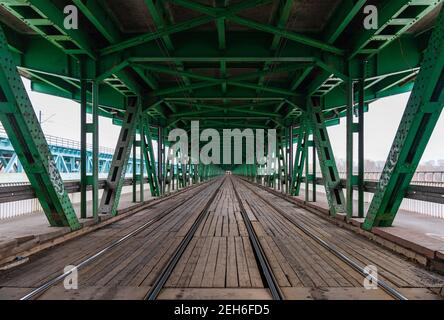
[[363, 9, 444, 230]]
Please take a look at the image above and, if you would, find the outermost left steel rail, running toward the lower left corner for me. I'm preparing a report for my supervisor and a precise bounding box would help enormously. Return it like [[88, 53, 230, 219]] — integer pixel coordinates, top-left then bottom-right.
[[20, 178, 220, 300]]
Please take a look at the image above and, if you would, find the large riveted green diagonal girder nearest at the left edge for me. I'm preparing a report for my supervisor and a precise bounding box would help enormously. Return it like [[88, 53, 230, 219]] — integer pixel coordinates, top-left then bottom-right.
[[0, 28, 81, 230]]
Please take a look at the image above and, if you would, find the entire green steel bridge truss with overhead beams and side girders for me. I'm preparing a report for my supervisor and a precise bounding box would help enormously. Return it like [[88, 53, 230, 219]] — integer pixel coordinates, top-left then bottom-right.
[[0, 0, 444, 229]]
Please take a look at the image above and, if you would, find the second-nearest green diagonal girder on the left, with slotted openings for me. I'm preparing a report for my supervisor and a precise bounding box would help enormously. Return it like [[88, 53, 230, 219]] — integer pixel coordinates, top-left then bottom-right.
[[99, 97, 142, 215]]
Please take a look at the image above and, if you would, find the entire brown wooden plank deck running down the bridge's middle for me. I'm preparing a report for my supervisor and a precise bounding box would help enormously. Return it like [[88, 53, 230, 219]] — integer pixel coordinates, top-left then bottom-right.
[[0, 176, 444, 299]]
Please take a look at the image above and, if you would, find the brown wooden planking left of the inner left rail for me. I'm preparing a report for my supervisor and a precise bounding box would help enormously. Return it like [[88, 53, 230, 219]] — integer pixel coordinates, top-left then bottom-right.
[[0, 181, 220, 299]]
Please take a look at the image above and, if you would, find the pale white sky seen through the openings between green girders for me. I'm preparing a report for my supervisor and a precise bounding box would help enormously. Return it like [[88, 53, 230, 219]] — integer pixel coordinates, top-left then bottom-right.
[[24, 79, 444, 161]]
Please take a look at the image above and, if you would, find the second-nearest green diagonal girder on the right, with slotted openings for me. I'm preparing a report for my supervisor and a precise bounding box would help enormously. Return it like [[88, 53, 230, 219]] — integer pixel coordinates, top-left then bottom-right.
[[306, 97, 345, 216]]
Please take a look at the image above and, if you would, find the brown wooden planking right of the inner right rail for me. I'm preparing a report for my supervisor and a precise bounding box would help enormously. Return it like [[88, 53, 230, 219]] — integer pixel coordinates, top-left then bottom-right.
[[236, 182, 444, 296]]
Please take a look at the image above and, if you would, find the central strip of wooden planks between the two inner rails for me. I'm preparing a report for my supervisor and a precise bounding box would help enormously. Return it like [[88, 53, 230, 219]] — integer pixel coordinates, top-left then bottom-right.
[[165, 179, 264, 292]]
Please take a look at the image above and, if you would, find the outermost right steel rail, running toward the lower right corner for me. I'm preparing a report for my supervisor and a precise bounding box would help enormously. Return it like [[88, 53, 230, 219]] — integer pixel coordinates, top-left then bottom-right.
[[241, 179, 408, 300]]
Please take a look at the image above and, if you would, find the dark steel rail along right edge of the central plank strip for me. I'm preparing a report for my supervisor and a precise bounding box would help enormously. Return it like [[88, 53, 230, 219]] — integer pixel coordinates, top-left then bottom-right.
[[230, 179, 285, 300]]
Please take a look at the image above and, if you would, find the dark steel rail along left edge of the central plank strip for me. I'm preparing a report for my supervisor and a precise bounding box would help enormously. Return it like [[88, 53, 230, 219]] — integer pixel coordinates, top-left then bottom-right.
[[144, 176, 224, 300]]
